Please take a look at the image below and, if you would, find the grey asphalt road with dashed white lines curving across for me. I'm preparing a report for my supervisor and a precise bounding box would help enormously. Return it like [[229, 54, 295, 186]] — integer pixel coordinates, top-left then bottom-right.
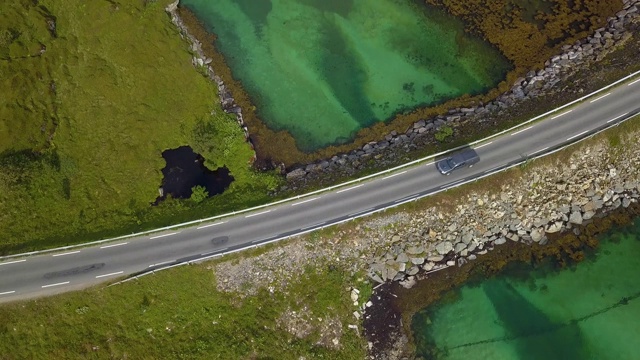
[[0, 76, 640, 302]]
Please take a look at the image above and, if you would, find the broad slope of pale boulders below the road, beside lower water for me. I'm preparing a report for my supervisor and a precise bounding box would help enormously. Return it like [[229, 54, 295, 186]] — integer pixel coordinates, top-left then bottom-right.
[[368, 141, 640, 286]]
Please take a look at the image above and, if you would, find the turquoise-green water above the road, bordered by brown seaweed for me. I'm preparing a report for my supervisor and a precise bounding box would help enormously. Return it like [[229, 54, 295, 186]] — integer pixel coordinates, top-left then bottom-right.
[[180, 0, 510, 151]]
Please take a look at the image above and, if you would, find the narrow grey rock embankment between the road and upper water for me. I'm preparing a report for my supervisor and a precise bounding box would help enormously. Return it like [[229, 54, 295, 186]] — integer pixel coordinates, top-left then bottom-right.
[[287, 0, 640, 183]]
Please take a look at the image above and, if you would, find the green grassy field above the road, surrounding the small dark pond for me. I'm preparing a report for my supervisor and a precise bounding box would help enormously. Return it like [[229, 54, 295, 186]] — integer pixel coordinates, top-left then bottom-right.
[[0, 0, 281, 254]]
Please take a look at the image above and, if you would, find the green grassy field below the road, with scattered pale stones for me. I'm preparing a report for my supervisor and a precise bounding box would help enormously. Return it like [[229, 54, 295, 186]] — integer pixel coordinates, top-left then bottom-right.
[[0, 264, 370, 360]]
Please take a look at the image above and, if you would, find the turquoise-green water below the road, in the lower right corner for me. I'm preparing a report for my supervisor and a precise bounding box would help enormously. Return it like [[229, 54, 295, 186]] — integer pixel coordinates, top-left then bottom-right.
[[412, 220, 640, 360]]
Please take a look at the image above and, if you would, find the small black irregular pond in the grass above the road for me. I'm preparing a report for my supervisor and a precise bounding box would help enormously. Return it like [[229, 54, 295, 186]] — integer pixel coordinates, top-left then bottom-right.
[[156, 146, 234, 203]]
